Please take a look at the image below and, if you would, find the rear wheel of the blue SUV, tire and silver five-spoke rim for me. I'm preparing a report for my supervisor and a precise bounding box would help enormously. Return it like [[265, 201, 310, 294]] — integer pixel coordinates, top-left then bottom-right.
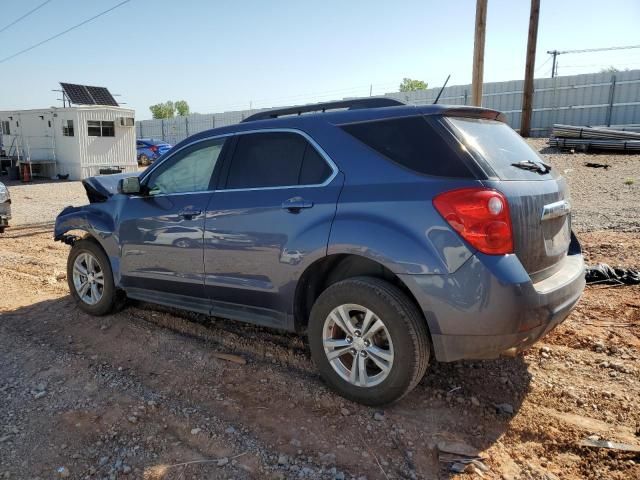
[[308, 277, 430, 406]]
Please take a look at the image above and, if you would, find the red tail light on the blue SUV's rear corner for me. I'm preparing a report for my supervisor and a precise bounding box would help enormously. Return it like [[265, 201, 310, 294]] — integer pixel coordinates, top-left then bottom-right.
[[433, 188, 513, 255]]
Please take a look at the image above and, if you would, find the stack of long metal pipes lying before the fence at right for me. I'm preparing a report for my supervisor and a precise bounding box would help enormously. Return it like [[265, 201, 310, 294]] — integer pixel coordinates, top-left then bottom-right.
[[549, 124, 640, 151]]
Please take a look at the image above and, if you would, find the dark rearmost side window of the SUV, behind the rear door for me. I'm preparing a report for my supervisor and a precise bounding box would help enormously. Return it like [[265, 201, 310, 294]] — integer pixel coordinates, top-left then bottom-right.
[[341, 117, 473, 178]]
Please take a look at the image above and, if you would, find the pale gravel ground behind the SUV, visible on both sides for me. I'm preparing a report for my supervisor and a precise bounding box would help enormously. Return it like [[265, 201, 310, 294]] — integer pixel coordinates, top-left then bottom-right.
[[0, 138, 640, 232]]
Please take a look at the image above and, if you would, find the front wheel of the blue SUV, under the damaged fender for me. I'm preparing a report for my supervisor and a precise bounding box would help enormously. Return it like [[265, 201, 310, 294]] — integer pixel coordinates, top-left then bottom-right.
[[67, 238, 122, 315]]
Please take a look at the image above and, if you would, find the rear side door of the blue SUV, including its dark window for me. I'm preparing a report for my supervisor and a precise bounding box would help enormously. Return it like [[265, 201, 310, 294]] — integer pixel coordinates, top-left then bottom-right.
[[204, 130, 343, 328]]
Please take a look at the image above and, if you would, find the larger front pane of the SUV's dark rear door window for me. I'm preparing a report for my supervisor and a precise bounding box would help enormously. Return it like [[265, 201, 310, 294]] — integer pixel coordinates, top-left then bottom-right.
[[227, 132, 307, 189]]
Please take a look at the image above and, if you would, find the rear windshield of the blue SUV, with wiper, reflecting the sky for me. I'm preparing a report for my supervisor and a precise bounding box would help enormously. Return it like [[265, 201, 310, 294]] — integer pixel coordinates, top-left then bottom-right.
[[447, 117, 551, 180]]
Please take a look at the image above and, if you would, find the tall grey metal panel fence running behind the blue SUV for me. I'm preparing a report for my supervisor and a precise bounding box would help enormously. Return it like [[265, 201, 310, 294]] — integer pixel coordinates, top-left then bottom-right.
[[136, 70, 640, 144]]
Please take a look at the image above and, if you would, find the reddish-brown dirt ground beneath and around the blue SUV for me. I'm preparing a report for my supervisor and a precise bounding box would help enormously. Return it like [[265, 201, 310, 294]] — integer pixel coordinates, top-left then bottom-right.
[[0, 141, 640, 480]]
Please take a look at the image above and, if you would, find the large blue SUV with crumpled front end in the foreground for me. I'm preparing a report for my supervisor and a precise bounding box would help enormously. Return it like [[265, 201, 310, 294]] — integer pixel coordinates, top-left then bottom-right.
[[55, 99, 585, 405]]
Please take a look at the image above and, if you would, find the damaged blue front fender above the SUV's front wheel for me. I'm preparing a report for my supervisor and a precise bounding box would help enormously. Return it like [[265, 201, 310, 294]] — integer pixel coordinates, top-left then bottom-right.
[[53, 203, 120, 285]]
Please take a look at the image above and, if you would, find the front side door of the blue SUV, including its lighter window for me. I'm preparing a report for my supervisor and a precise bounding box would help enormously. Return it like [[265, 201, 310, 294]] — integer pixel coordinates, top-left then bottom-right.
[[119, 138, 226, 310]]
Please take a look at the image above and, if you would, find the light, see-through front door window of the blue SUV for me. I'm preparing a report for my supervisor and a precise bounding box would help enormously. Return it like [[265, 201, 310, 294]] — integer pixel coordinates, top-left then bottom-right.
[[147, 138, 225, 195]]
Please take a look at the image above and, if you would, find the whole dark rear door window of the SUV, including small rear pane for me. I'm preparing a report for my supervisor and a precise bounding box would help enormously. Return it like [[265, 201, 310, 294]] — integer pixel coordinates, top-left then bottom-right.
[[227, 132, 331, 189]]
